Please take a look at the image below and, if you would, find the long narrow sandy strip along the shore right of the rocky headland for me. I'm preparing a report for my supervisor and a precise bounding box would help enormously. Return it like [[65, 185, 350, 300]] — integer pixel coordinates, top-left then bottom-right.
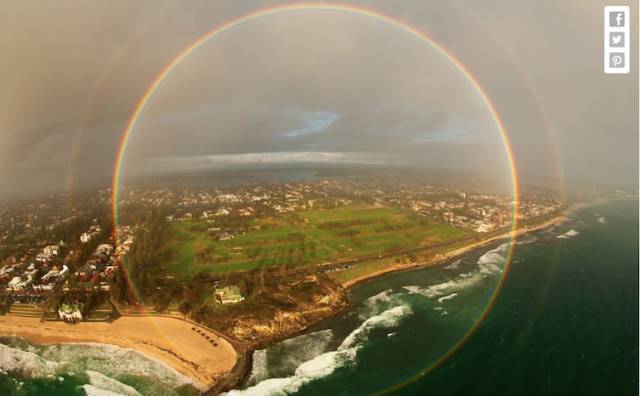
[[342, 213, 578, 288]]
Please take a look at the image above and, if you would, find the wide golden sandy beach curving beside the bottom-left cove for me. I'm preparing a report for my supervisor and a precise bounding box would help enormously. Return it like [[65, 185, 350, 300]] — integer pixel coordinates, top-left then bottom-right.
[[0, 315, 236, 390]]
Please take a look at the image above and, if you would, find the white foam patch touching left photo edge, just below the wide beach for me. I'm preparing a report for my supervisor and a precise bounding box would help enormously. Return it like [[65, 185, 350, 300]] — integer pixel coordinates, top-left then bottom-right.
[[0, 344, 64, 378]]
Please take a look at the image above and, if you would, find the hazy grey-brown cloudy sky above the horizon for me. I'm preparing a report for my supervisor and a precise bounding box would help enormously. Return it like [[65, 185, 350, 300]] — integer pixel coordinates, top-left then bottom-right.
[[0, 0, 638, 199]]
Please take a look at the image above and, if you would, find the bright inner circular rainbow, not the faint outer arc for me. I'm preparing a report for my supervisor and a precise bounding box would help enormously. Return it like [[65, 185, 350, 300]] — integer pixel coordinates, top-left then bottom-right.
[[111, 3, 520, 393]]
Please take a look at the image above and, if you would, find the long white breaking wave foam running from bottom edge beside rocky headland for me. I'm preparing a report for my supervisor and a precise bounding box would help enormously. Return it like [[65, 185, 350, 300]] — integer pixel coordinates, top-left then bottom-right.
[[227, 304, 412, 396]]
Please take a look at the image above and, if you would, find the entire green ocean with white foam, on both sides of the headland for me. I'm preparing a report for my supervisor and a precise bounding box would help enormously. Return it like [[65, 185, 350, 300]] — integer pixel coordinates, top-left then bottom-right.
[[0, 201, 639, 395]]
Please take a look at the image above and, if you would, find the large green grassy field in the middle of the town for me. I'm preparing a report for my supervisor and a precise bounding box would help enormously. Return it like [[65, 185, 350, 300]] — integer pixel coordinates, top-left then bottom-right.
[[166, 206, 473, 275]]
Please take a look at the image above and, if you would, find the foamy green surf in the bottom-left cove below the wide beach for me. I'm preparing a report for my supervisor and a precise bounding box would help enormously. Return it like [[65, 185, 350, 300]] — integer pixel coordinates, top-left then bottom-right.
[[0, 338, 200, 396]]
